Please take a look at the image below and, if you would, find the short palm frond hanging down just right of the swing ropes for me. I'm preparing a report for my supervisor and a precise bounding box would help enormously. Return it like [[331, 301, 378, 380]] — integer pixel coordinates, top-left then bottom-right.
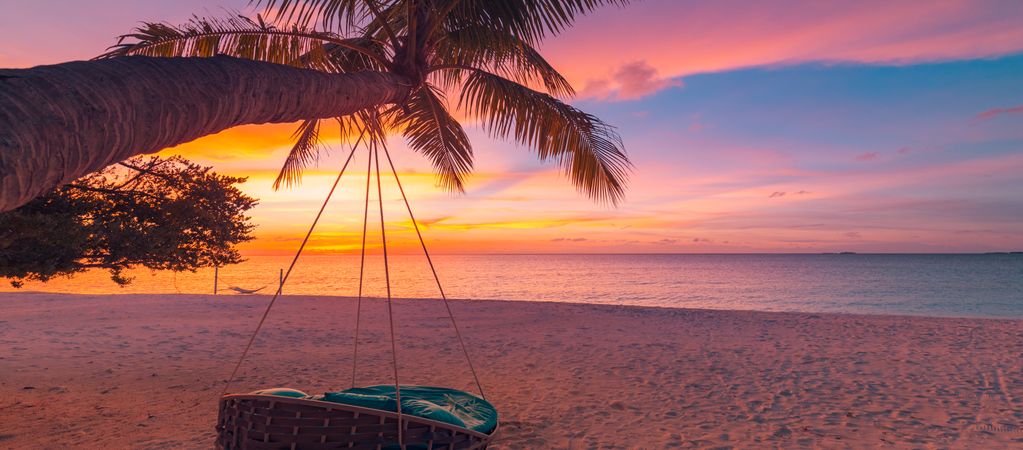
[[395, 85, 473, 192]]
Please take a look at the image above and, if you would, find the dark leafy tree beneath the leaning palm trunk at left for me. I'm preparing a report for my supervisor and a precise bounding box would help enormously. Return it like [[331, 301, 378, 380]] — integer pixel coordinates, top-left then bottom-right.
[[0, 156, 257, 287]]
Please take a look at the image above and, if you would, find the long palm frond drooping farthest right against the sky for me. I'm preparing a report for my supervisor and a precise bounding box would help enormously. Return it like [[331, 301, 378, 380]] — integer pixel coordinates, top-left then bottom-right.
[[459, 71, 631, 205]]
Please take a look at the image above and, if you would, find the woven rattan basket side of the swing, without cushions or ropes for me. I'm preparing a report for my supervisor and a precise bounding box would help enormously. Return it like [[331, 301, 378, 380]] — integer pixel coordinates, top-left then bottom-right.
[[217, 394, 496, 450]]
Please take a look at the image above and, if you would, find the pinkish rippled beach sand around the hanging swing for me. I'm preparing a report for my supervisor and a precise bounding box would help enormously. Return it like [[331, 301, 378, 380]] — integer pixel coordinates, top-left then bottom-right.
[[0, 293, 1023, 449]]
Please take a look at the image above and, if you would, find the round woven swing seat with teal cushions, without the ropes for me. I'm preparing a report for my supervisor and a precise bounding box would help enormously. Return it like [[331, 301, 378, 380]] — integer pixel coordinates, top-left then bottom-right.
[[217, 386, 497, 450]]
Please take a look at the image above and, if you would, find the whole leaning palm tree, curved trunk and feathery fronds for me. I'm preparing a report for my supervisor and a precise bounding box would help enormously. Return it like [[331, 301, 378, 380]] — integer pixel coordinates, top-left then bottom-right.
[[0, 0, 629, 211]]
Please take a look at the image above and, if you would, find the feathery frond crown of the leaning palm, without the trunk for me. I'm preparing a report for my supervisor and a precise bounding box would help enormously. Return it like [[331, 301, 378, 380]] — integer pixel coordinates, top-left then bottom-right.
[[102, 0, 631, 204]]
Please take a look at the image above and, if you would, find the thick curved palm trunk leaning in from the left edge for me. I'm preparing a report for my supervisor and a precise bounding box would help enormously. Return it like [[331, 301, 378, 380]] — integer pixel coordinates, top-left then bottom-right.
[[0, 56, 409, 212]]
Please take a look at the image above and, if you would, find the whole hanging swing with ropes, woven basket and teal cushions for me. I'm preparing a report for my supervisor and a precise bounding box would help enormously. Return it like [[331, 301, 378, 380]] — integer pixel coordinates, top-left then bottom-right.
[[216, 146, 497, 450]]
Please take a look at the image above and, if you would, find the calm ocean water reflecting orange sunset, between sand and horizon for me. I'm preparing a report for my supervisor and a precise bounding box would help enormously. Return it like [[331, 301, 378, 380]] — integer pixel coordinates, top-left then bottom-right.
[[0, 254, 1023, 318]]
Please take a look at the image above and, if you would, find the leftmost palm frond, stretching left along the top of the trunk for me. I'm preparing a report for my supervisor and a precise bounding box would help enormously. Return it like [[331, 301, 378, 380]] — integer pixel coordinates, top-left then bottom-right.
[[99, 15, 385, 72]]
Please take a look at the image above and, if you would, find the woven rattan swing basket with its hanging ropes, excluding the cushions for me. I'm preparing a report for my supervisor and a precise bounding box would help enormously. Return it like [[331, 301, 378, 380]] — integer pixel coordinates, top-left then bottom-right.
[[216, 146, 497, 450]]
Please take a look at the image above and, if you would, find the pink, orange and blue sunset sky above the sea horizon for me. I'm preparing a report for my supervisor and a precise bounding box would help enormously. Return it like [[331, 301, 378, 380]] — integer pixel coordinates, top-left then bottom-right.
[[0, 0, 1023, 254]]
